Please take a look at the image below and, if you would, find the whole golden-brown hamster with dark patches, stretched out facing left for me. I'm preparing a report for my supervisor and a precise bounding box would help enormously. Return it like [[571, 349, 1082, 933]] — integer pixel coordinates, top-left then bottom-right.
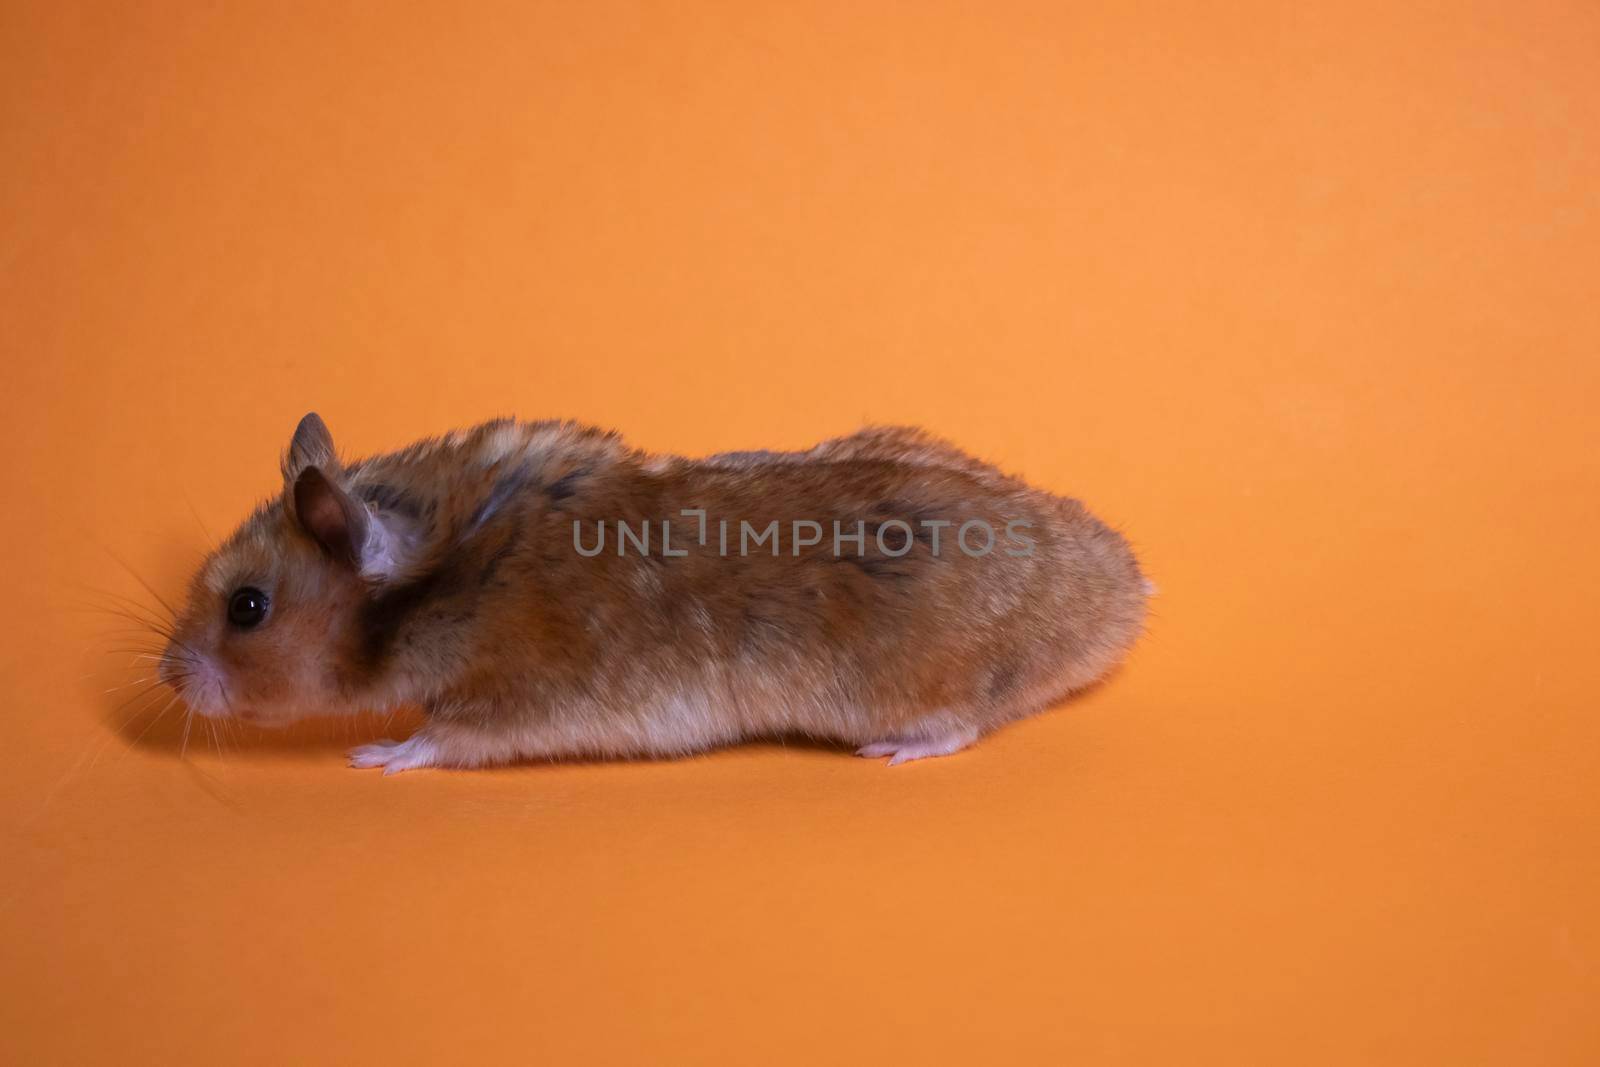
[[160, 414, 1150, 774]]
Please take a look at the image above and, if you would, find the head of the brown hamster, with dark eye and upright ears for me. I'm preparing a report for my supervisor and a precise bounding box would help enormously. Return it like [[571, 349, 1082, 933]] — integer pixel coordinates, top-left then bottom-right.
[[158, 414, 409, 725]]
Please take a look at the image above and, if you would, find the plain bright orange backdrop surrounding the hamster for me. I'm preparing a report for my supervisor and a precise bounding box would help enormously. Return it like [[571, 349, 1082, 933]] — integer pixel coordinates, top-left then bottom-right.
[[0, 2, 1600, 1064]]
